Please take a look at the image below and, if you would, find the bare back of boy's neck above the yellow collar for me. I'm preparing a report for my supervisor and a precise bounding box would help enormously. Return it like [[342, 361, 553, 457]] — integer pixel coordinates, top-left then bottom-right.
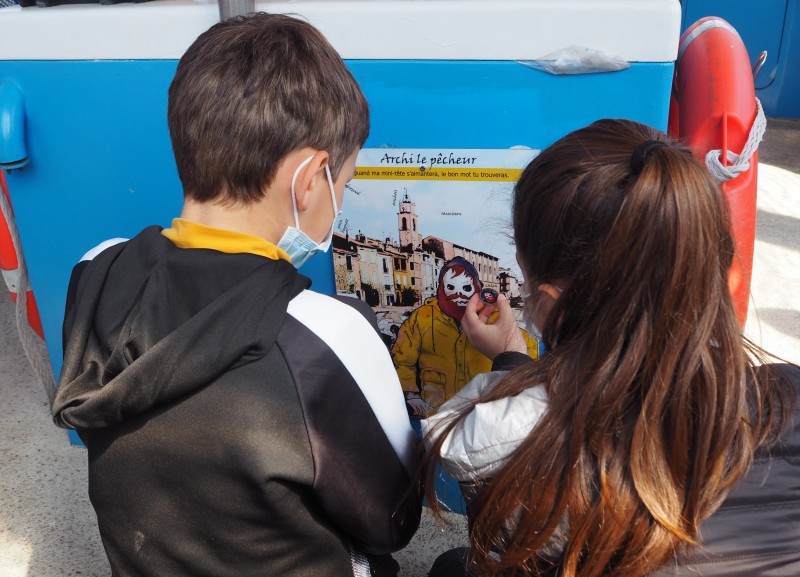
[[181, 199, 286, 243]]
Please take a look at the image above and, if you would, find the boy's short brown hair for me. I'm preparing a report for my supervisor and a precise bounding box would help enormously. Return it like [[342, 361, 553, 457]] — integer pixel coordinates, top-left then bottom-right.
[[168, 13, 369, 204]]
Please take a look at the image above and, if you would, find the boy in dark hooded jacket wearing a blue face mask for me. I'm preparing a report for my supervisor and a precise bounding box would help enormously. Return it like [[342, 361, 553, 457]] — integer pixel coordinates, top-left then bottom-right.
[[53, 13, 420, 577]]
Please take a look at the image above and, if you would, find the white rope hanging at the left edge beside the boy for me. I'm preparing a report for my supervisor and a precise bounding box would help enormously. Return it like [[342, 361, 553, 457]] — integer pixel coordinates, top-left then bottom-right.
[[0, 184, 56, 404]]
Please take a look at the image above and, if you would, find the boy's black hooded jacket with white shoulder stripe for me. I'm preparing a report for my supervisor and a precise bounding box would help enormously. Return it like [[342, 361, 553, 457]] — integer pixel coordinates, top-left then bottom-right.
[[53, 227, 420, 577]]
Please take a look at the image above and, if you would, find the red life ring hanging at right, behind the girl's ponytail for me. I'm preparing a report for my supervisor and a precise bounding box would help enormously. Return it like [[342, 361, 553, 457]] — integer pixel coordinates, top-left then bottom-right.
[[668, 16, 763, 326]]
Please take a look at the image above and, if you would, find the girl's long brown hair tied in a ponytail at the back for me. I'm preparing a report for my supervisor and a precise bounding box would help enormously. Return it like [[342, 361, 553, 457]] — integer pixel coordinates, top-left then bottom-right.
[[424, 120, 789, 577]]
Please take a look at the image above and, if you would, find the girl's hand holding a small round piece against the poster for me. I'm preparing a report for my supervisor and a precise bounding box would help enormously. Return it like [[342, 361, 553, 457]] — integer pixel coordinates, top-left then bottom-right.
[[461, 294, 528, 360]]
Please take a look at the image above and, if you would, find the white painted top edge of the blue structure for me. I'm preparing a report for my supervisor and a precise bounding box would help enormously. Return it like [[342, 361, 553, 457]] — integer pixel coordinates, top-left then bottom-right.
[[0, 0, 680, 62]]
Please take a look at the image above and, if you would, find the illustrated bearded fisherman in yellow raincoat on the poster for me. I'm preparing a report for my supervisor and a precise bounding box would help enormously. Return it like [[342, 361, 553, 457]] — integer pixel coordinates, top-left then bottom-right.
[[392, 257, 538, 417]]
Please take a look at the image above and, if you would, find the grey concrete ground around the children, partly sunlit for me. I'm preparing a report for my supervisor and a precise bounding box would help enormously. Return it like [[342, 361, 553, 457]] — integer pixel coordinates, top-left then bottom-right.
[[0, 119, 800, 577]]
